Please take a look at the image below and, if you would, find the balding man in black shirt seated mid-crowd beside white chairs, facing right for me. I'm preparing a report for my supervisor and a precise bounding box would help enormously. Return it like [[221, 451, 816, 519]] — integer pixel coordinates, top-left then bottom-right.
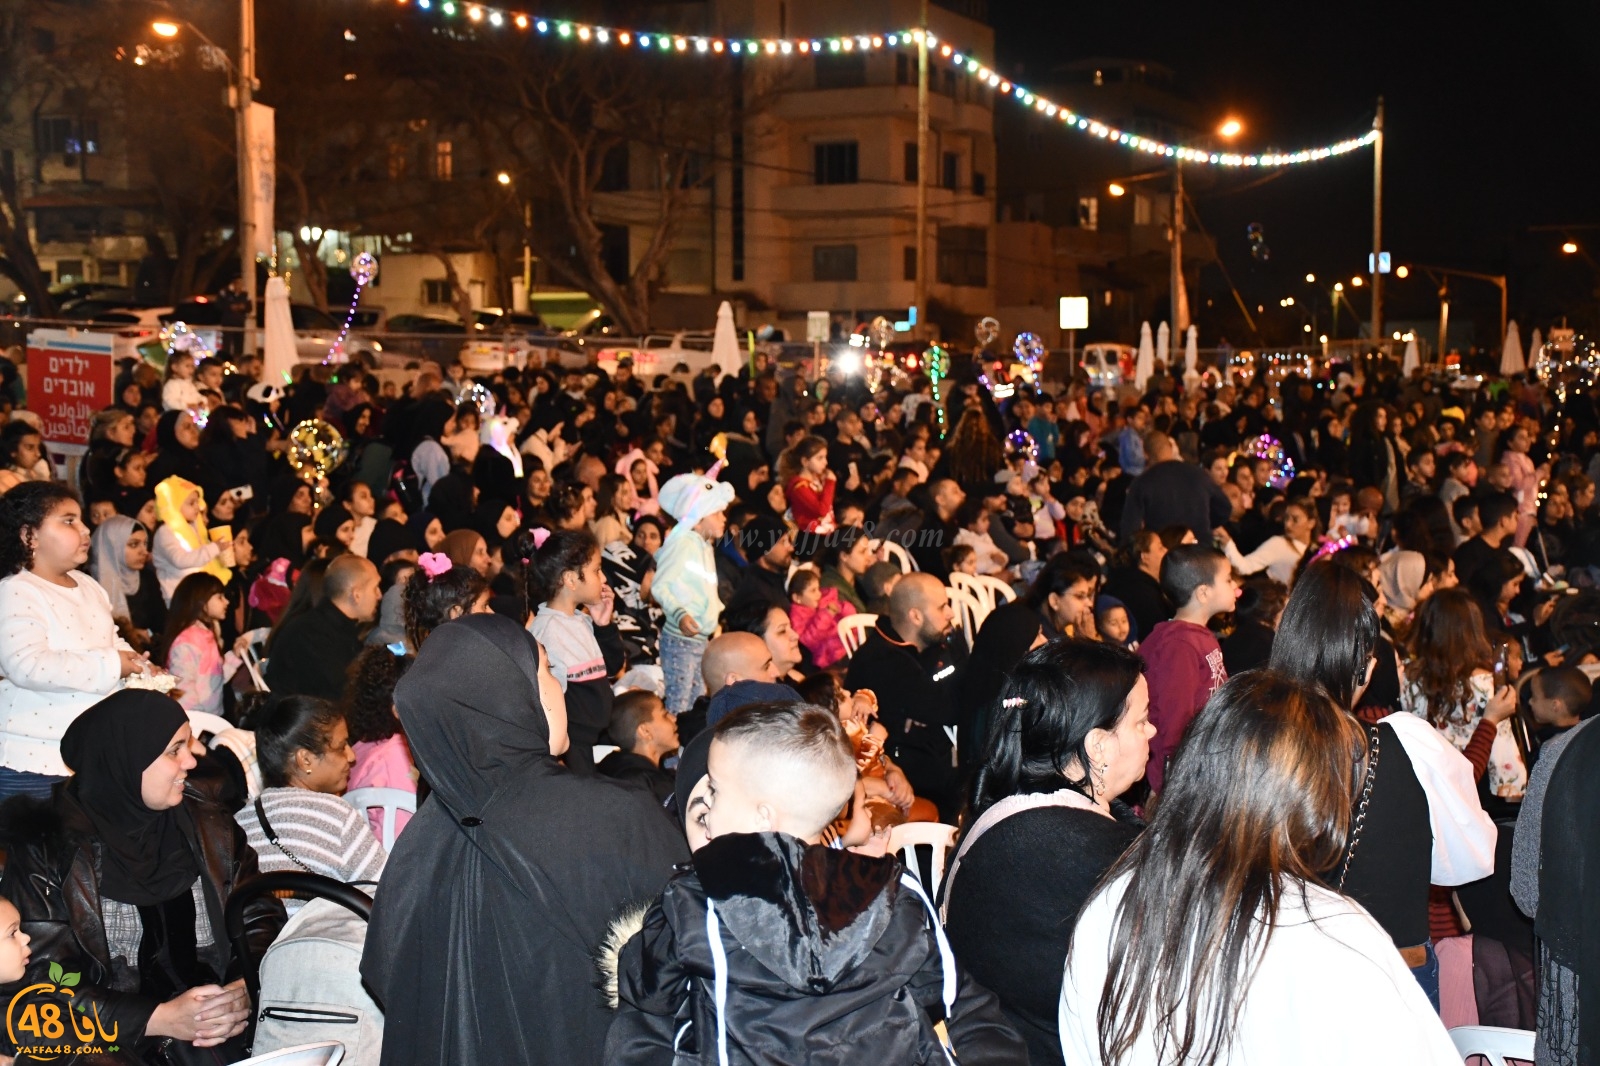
[[845, 573, 966, 813]]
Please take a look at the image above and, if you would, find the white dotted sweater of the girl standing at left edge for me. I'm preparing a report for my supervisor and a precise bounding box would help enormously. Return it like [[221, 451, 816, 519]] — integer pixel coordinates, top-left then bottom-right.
[[0, 570, 133, 776]]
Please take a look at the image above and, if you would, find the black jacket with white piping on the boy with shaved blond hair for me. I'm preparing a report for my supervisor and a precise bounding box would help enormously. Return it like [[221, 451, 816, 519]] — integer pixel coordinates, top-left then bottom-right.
[[605, 832, 1027, 1066]]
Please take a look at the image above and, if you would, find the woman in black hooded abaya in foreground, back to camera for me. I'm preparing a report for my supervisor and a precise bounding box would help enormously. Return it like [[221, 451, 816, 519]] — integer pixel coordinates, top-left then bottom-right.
[[362, 615, 688, 1066]]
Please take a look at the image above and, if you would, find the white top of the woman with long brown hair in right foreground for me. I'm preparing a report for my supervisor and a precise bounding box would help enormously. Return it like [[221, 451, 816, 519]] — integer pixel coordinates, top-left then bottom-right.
[[1058, 876, 1461, 1066]]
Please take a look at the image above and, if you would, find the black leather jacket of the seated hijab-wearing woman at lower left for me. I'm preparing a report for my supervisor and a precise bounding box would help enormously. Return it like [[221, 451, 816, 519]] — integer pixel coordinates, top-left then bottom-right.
[[0, 783, 285, 1055]]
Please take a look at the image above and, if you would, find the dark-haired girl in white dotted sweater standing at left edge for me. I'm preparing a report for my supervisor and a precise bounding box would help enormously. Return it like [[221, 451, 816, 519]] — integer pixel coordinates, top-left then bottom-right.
[[0, 482, 146, 799]]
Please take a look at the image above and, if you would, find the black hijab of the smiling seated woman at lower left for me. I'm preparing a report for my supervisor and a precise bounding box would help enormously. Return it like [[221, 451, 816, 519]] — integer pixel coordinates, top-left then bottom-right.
[[61, 688, 200, 906]]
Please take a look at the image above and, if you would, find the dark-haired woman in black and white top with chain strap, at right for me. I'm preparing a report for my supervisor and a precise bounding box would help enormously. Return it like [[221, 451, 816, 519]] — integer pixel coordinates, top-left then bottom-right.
[[1272, 562, 1494, 1007]]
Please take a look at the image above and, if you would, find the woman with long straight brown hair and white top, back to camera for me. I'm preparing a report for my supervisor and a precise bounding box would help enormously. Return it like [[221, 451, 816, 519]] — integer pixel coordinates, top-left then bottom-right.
[[1058, 671, 1461, 1066]]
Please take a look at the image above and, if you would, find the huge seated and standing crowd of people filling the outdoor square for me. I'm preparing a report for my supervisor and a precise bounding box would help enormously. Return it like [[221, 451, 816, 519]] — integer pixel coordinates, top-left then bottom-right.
[[0, 337, 1600, 1066]]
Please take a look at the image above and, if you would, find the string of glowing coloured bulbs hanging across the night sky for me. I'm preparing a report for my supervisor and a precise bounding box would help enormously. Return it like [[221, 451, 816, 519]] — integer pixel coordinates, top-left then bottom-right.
[[380, 0, 1378, 168]]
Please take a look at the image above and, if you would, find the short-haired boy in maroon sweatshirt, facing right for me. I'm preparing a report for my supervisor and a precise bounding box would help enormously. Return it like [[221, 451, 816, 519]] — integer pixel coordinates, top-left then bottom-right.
[[1139, 544, 1238, 792]]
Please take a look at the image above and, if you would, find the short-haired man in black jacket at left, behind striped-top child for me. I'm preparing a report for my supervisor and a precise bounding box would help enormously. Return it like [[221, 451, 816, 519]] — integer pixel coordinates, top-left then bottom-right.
[[267, 555, 382, 699]]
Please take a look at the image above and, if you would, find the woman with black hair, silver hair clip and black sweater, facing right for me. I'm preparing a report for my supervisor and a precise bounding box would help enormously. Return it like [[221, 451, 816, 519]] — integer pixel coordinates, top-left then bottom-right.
[[944, 640, 1155, 1064]]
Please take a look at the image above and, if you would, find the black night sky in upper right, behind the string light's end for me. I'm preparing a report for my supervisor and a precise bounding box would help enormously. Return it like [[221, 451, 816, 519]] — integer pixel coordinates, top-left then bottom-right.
[[990, 0, 1600, 343]]
